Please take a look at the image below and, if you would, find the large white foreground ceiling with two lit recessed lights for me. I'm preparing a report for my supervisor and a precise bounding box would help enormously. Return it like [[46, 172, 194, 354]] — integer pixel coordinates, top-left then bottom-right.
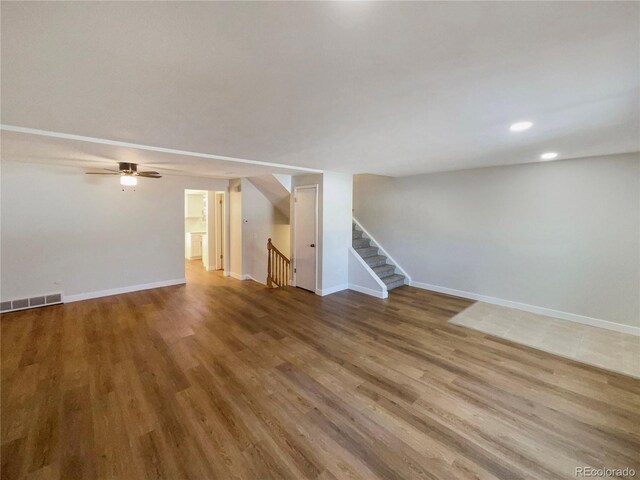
[[1, 1, 640, 175]]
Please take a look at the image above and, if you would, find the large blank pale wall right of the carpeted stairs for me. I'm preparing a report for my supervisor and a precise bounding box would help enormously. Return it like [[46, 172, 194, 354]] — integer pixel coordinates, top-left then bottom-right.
[[354, 154, 640, 327]]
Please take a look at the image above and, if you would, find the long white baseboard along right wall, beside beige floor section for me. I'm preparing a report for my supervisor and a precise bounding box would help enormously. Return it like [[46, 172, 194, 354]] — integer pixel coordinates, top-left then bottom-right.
[[411, 282, 640, 336]]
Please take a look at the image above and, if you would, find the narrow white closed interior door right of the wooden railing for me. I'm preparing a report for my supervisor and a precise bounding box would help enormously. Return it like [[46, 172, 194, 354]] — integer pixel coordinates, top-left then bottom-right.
[[293, 185, 318, 292]]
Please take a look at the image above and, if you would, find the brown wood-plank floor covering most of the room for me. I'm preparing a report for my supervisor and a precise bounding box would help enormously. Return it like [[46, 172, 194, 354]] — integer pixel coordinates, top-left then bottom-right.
[[1, 264, 640, 480]]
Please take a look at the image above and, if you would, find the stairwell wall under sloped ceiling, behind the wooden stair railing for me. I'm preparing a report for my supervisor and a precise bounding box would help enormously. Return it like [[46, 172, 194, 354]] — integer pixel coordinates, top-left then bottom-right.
[[241, 178, 289, 283]]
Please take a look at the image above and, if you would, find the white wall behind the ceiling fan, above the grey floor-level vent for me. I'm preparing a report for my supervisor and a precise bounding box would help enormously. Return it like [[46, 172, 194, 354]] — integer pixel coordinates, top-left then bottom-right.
[[0, 159, 228, 300]]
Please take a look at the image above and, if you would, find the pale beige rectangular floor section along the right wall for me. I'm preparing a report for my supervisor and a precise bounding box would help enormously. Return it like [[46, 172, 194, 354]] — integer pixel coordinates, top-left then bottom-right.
[[450, 302, 640, 377]]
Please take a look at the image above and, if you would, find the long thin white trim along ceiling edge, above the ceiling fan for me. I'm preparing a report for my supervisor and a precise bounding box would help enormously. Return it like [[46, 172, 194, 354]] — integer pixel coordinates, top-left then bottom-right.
[[0, 124, 322, 173]]
